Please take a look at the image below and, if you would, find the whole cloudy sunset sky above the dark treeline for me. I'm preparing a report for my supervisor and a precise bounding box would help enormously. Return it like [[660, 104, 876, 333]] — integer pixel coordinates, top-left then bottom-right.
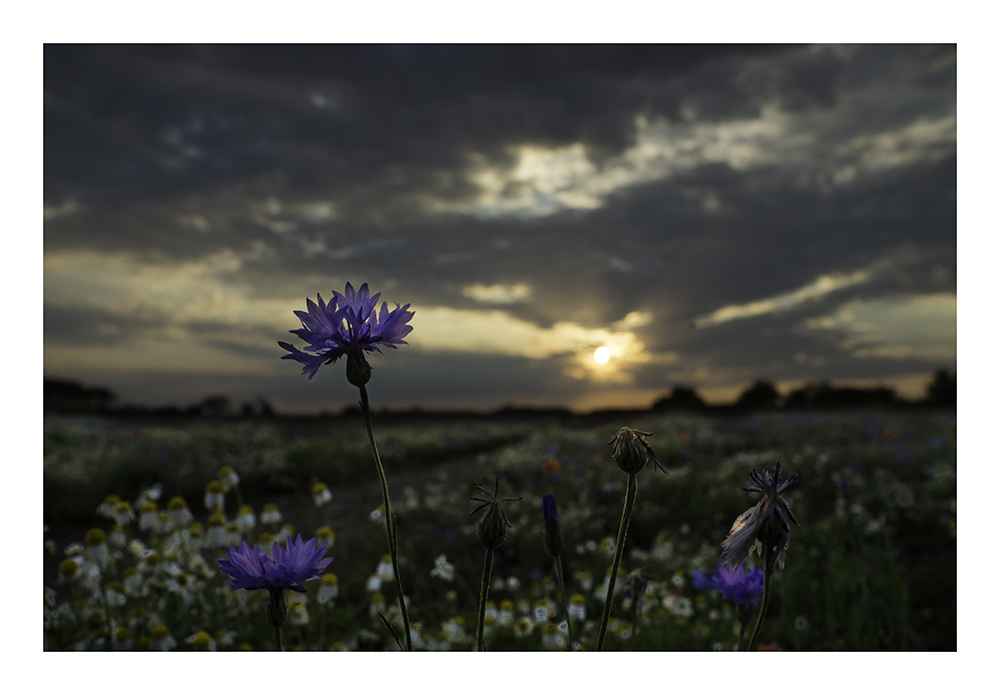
[[42, 44, 957, 412]]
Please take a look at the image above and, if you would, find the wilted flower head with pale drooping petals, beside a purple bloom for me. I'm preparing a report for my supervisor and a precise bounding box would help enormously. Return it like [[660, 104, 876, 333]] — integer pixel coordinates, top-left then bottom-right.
[[722, 463, 799, 571]]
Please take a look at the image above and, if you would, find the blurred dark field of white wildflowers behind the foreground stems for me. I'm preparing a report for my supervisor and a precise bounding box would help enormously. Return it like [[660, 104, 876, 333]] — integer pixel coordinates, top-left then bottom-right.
[[44, 408, 956, 650]]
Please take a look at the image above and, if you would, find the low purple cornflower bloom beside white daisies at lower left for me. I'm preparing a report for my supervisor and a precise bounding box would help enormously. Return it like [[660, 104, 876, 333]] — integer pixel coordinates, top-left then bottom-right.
[[218, 534, 332, 593]]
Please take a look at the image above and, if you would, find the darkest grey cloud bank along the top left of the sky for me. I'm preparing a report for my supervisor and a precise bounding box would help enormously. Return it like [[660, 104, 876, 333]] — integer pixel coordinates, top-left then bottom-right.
[[45, 46, 787, 219]]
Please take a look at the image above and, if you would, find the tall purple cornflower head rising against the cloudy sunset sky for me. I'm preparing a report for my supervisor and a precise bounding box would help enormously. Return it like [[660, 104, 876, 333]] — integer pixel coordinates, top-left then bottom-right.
[[278, 283, 414, 386]]
